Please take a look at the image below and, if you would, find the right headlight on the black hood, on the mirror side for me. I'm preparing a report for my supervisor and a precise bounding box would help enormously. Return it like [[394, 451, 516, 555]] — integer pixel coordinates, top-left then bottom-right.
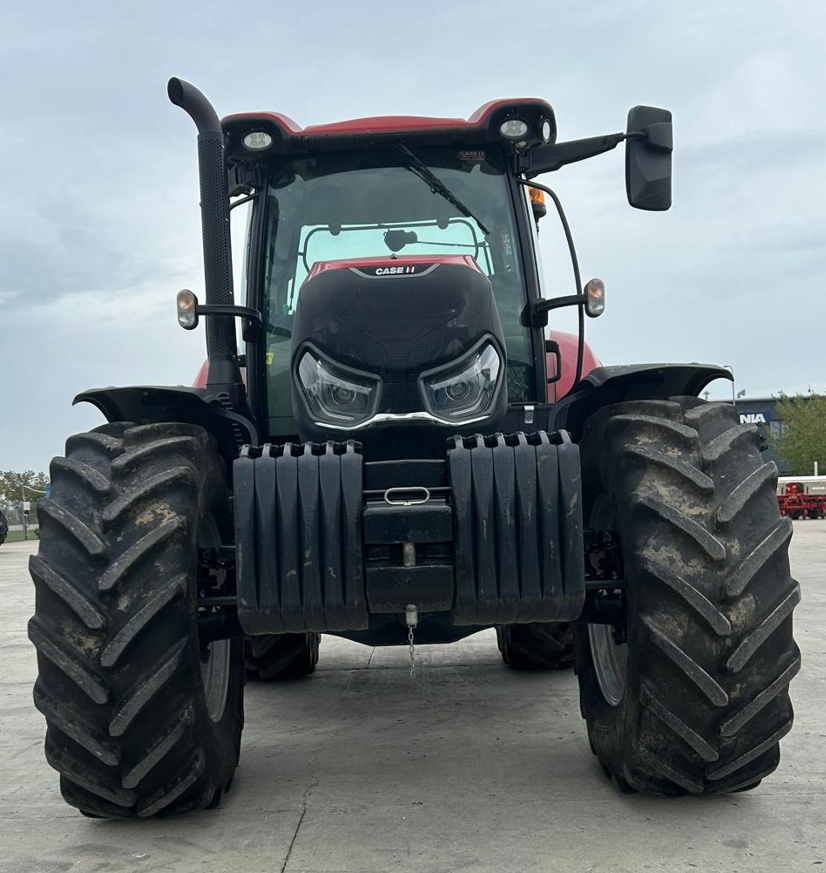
[[421, 343, 502, 422]]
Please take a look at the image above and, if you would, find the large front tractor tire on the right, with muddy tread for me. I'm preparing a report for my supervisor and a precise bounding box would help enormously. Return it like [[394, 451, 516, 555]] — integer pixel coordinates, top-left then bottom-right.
[[574, 397, 800, 795]]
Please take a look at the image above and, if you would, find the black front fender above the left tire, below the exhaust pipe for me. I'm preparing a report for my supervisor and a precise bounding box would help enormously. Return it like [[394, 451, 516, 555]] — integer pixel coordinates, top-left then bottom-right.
[[77, 385, 260, 471]]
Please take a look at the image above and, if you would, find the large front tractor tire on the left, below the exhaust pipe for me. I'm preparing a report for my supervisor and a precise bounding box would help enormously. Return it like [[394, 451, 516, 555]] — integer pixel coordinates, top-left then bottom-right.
[[29, 424, 244, 818]]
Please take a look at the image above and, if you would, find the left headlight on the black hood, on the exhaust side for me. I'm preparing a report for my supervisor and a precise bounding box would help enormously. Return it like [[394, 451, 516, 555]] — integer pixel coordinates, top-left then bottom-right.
[[298, 352, 379, 425]]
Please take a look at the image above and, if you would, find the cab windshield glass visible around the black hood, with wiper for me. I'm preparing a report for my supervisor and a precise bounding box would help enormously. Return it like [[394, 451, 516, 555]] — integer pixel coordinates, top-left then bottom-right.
[[263, 147, 532, 435]]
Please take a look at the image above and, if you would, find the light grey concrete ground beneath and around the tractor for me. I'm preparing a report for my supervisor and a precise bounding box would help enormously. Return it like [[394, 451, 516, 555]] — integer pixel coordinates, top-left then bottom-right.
[[0, 521, 826, 873]]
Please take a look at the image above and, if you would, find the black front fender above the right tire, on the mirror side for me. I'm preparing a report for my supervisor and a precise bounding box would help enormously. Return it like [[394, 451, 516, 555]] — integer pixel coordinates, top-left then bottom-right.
[[548, 364, 734, 442]]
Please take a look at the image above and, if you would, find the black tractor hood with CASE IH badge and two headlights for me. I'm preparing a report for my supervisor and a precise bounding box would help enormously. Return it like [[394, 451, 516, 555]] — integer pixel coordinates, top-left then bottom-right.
[[291, 256, 507, 452]]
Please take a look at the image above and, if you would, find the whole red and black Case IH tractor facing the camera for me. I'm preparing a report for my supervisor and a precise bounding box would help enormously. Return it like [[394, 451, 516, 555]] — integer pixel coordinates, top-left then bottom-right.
[[29, 79, 800, 818]]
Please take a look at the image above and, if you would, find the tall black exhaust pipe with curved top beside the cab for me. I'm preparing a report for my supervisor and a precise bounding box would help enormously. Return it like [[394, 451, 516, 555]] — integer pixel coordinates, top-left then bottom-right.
[[166, 78, 241, 384]]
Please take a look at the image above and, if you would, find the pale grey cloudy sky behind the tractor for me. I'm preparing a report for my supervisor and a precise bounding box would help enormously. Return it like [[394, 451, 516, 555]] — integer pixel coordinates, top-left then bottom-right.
[[0, 0, 826, 470]]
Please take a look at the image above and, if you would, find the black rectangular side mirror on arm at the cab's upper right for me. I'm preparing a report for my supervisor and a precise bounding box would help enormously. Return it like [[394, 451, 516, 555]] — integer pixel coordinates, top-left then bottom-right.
[[625, 106, 674, 212]]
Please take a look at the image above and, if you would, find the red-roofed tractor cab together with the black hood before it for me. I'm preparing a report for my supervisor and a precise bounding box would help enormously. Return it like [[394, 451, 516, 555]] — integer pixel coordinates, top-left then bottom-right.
[[223, 100, 555, 454]]
